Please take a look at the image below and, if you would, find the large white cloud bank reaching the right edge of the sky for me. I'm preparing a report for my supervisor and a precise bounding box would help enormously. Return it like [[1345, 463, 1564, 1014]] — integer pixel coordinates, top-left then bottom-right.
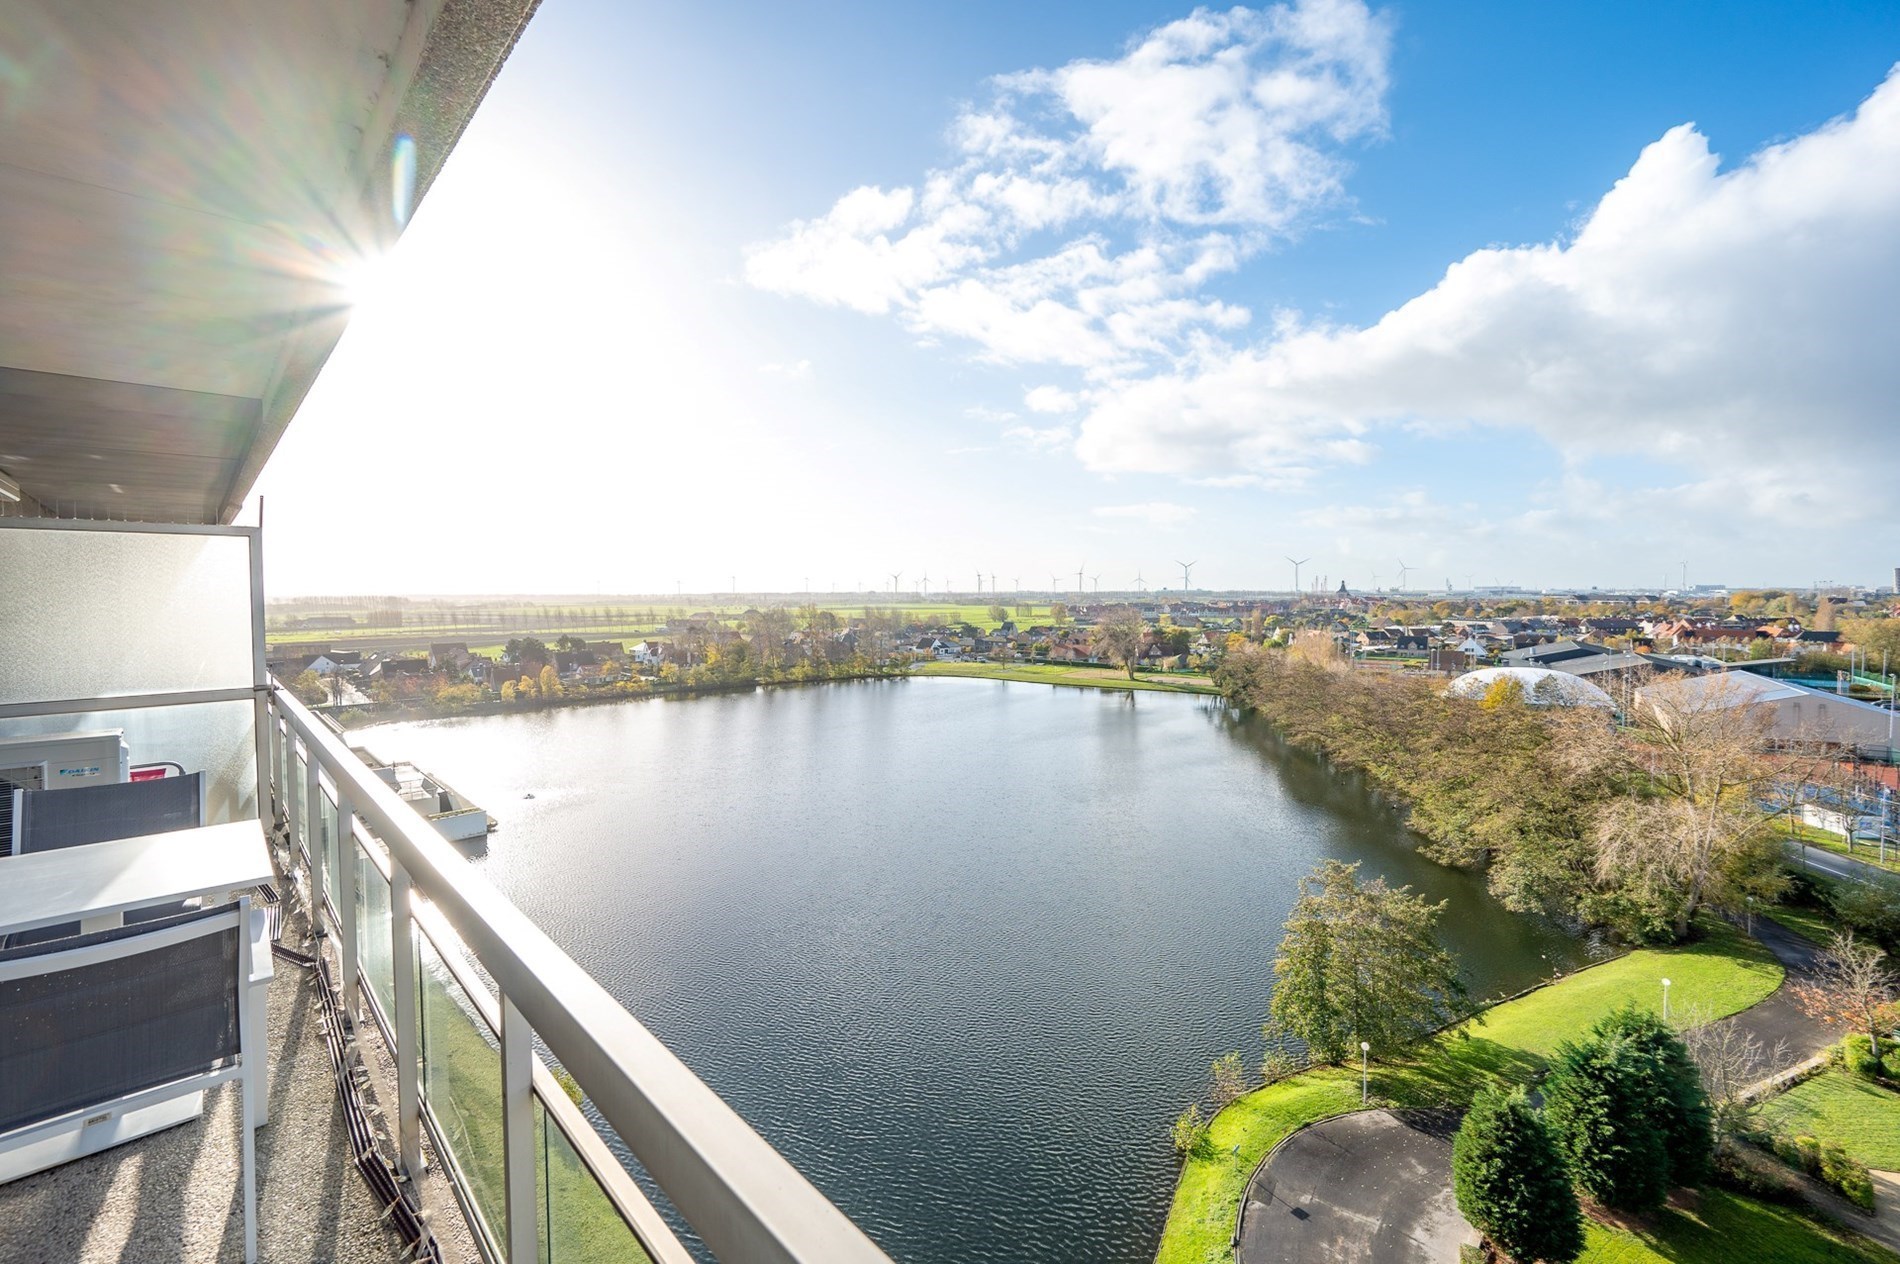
[[1075, 70, 1900, 501]]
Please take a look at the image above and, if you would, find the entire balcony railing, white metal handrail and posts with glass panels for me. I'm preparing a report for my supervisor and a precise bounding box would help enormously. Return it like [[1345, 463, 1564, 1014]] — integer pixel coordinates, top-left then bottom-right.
[[258, 682, 887, 1264]]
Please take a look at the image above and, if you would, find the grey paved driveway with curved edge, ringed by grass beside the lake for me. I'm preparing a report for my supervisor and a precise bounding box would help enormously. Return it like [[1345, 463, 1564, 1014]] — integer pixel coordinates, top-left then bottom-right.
[[1233, 1110, 1478, 1264]]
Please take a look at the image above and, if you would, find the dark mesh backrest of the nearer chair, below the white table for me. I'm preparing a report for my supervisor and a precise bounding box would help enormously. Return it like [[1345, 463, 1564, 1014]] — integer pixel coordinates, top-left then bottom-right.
[[0, 897, 247, 1135]]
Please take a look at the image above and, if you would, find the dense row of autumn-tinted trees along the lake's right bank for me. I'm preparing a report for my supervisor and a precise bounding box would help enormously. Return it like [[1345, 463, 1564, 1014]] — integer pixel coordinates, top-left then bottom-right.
[[1214, 633, 1832, 943]]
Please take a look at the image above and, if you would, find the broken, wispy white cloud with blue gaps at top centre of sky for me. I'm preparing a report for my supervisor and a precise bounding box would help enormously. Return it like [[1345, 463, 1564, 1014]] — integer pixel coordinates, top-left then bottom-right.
[[745, 0, 1389, 376]]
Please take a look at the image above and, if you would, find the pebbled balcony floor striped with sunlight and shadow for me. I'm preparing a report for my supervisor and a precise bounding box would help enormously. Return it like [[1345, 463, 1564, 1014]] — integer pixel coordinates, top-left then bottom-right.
[[0, 908, 431, 1264]]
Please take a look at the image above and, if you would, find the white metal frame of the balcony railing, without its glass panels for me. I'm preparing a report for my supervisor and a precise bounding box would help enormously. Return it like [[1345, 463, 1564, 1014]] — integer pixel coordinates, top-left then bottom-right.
[[258, 682, 889, 1264]]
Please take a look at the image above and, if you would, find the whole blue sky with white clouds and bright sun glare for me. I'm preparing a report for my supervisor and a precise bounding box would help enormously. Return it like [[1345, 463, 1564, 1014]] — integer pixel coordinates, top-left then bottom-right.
[[257, 0, 1900, 597]]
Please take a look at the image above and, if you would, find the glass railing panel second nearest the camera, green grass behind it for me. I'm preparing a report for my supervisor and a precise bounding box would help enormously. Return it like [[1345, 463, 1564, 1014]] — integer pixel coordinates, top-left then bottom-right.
[[416, 928, 507, 1241]]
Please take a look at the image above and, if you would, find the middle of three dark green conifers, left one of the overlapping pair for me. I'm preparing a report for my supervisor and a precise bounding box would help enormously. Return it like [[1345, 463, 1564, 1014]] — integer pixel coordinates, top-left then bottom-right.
[[1545, 1040, 1670, 1211]]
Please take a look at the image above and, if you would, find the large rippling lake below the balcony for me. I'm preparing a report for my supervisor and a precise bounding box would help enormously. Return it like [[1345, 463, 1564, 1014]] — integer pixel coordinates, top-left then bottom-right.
[[357, 677, 1587, 1264]]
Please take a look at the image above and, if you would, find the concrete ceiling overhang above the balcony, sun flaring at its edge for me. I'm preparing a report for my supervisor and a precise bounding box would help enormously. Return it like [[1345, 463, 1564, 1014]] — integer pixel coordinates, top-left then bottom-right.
[[0, 0, 538, 523]]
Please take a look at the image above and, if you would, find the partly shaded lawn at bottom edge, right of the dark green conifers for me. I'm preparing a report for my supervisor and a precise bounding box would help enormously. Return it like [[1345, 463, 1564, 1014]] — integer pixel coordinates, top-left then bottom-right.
[[1577, 1188, 1894, 1264]]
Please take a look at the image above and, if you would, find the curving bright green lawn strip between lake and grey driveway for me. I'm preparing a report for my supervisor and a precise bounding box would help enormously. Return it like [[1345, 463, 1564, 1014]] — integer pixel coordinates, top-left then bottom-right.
[[1155, 922, 1782, 1264]]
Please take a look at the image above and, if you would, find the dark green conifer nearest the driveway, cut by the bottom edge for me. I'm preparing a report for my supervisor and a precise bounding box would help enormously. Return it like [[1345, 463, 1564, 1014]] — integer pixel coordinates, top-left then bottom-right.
[[1452, 1087, 1583, 1264]]
